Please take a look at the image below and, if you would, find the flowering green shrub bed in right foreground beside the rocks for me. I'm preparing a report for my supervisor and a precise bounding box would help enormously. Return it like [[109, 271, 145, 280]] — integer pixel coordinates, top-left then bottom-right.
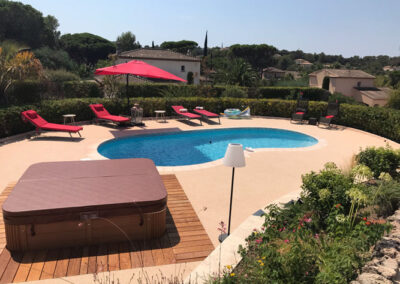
[[216, 159, 394, 284]]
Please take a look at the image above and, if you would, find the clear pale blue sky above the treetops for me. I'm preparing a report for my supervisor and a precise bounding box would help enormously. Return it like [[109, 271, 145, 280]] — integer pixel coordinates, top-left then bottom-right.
[[21, 0, 400, 57]]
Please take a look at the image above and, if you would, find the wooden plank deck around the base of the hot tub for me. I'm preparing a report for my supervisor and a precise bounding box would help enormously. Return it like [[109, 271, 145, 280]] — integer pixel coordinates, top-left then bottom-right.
[[0, 175, 214, 283]]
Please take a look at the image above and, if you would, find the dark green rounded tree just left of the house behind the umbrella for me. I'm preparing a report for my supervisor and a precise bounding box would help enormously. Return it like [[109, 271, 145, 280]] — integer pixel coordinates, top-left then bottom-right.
[[60, 33, 115, 65]]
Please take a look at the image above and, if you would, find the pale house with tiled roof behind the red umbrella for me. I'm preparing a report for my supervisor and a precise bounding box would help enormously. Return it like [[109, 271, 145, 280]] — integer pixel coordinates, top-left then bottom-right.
[[115, 48, 200, 84]]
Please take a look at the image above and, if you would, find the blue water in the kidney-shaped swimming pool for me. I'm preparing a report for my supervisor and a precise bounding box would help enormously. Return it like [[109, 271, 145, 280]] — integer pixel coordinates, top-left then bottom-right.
[[97, 128, 318, 166]]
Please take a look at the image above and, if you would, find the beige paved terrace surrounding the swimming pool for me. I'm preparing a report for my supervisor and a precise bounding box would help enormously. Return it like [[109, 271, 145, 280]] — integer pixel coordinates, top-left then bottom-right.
[[0, 118, 400, 282]]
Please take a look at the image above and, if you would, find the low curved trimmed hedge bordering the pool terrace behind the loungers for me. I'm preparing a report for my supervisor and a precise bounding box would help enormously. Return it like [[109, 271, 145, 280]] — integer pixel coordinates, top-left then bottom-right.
[[0, 97, 400, 142]]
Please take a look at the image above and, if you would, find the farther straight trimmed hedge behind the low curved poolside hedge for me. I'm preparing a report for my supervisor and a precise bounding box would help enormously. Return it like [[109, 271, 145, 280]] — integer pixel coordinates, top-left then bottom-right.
[[3, 81, 329, 105]]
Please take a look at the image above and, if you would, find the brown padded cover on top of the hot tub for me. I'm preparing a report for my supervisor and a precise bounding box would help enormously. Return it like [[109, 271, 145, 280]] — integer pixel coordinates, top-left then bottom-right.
[[3, 159, 167, 224]]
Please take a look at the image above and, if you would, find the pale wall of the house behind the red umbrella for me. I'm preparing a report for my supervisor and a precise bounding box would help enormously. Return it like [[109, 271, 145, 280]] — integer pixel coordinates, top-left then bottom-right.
[[116, 59, 200, 84]]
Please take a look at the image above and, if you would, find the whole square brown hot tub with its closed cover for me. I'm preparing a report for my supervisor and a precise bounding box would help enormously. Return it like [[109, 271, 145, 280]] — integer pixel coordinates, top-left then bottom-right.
[[3, 159, 167, 251]]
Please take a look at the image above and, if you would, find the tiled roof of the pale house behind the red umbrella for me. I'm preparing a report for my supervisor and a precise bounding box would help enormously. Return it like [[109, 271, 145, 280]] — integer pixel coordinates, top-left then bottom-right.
[[118, 48, 200, 62]]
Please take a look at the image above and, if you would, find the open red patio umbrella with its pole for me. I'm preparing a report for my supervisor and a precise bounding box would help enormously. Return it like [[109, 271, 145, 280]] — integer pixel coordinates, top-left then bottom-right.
[[94, 60, 186, 109]]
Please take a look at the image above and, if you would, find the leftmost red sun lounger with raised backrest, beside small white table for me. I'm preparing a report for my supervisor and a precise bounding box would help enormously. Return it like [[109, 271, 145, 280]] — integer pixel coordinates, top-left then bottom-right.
[[21, 110, 83, 137]]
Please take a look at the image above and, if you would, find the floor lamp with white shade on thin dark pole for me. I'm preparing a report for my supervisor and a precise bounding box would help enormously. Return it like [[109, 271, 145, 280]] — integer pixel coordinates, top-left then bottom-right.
[[218, 143, 246, 243]]
